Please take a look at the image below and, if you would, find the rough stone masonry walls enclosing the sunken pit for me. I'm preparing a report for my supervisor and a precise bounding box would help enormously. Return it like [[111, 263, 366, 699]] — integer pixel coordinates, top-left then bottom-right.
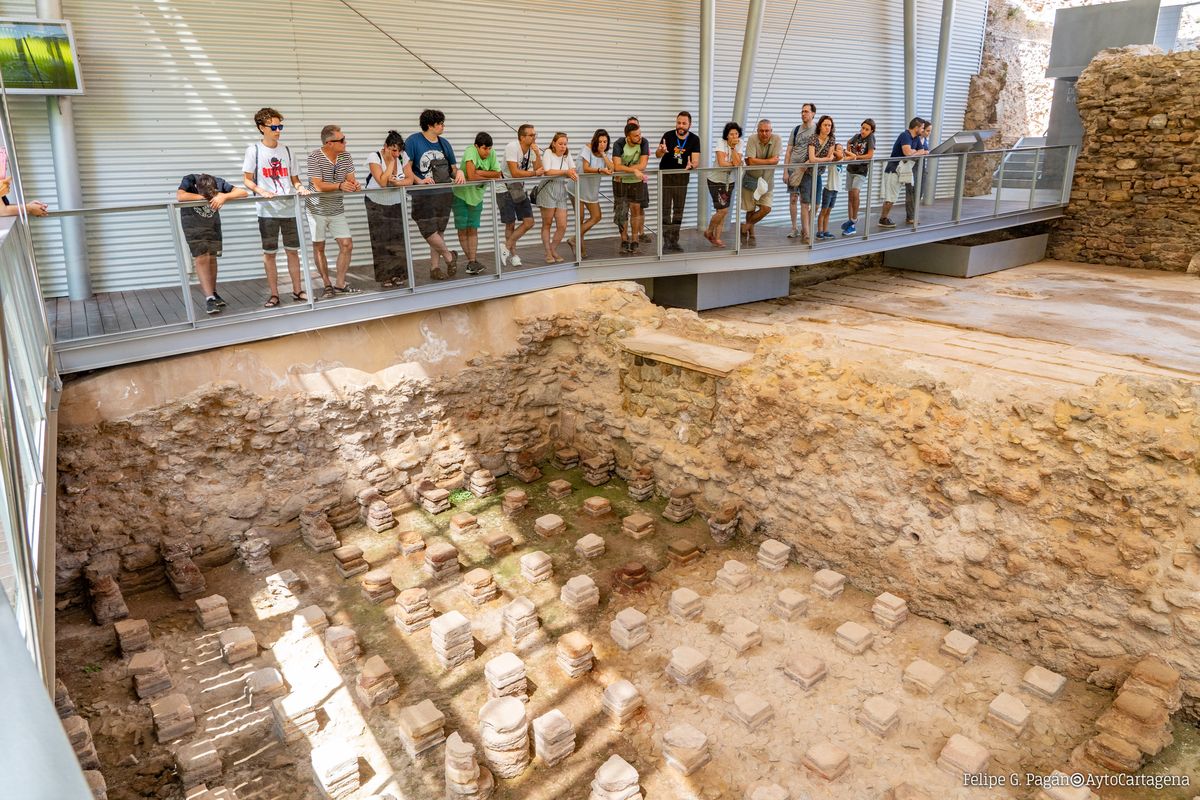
[[58, 284, 1200, 716]]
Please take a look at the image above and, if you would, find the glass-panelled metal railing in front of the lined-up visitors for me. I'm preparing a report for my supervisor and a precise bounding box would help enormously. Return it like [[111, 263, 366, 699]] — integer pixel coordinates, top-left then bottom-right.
[[32, 145, 1074, 343]]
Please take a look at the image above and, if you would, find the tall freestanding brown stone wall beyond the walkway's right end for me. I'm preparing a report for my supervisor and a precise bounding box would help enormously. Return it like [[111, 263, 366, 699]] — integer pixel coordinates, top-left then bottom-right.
[[1050, 47, 1200, 271]]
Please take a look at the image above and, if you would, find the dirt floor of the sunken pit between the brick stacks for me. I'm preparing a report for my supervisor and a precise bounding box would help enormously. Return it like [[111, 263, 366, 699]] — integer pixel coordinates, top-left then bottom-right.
[[58, 469, 1200, 800]]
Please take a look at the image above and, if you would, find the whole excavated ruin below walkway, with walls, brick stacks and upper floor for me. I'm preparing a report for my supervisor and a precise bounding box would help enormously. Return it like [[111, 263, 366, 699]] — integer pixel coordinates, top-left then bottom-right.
[[46, 268, 1200, 800]]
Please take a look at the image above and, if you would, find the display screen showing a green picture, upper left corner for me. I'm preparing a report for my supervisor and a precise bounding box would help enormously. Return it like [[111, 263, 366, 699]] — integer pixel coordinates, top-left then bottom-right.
[[0, 19, 83, 95]]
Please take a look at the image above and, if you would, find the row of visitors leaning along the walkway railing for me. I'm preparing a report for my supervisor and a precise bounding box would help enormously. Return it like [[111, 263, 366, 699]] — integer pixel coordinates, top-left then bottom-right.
[[176, 103, 929, 314]]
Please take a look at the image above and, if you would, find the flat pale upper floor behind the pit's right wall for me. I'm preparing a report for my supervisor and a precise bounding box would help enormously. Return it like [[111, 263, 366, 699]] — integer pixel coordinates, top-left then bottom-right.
[[702, 260, 1200, 396]]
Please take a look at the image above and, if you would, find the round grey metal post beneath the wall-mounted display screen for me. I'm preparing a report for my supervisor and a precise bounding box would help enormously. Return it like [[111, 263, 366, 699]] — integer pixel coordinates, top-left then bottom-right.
[[37, 0, 91, 300]]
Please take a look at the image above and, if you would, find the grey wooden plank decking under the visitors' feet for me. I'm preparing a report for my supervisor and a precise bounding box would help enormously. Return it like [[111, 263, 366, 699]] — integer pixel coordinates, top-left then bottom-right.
[[46, 198, 1026, 342]]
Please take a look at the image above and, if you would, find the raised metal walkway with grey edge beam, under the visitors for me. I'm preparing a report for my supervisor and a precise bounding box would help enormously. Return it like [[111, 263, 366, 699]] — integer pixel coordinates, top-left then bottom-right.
[[46, 151, 1069, 373]]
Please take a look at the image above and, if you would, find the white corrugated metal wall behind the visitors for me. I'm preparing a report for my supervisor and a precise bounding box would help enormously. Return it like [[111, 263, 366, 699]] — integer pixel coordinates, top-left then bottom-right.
[[0, 0, 986, 295]]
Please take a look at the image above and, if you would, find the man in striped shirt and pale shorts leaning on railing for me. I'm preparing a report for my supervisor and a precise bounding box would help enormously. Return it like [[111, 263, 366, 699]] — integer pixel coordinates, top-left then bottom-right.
[[308, 125, 362, 299]]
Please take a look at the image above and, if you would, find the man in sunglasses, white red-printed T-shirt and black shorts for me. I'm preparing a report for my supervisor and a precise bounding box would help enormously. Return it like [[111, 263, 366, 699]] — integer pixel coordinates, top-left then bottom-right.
[[241, 108, 308, 308]]
